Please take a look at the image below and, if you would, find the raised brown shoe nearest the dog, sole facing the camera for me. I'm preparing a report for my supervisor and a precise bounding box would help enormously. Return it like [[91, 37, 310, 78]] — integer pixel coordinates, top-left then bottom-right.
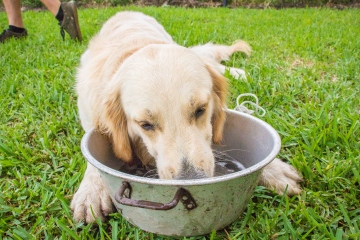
[[59, 1, 82, 42]]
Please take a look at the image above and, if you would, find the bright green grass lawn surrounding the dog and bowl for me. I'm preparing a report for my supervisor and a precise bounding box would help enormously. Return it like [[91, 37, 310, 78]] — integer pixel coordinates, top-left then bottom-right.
[[0, 7, 360, 240]]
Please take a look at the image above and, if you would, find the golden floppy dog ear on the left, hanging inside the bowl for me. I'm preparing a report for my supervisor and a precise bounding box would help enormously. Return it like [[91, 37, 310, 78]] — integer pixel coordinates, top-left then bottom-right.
[[95, 92, 133, 163]]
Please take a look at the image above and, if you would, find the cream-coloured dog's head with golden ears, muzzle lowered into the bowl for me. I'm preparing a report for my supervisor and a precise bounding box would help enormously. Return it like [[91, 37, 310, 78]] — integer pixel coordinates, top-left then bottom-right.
[[99, 44, 227, 179]]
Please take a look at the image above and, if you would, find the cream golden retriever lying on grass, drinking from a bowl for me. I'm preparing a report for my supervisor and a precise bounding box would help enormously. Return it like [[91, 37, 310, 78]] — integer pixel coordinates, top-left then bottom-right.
[[71, 12, 301, 222]]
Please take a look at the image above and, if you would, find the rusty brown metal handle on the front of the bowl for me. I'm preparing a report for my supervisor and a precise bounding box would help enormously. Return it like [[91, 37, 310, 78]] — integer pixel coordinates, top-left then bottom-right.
[[115, 181, 196, 210]]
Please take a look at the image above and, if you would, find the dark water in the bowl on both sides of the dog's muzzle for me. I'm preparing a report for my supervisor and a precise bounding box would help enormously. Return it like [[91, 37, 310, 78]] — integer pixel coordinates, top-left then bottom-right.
[[120, 151, 245, 179]]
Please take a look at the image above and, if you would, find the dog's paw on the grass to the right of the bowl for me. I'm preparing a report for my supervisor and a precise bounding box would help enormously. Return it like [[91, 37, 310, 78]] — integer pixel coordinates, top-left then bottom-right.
[[259, 158, 302, 196]]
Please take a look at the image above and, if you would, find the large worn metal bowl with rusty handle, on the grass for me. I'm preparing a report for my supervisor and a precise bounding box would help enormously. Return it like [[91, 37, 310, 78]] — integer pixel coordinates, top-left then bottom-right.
[[81, 110, 281, 236]]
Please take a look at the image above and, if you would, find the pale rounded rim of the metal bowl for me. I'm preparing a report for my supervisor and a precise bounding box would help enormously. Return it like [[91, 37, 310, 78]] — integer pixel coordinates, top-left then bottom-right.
[[81, 109, 281, 186]]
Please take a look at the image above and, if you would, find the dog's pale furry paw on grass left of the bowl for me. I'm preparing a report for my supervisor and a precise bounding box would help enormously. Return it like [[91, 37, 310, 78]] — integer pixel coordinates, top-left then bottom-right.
[[70, 164, 114, 223]]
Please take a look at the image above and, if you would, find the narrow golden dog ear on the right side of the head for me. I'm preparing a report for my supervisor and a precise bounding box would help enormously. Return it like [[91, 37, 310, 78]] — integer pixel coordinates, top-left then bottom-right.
[[206, 65, 228, 143]]
